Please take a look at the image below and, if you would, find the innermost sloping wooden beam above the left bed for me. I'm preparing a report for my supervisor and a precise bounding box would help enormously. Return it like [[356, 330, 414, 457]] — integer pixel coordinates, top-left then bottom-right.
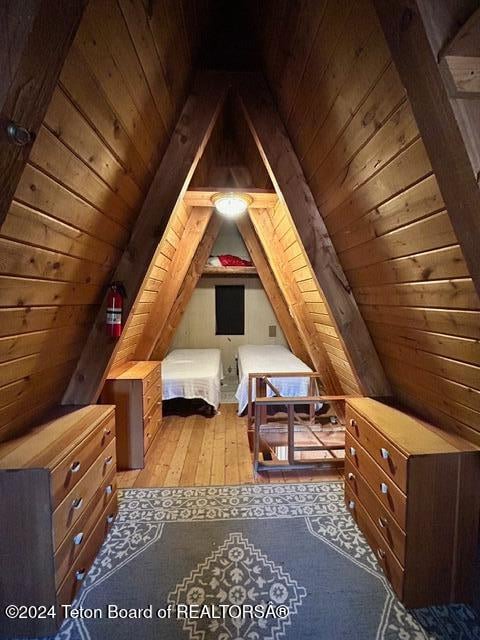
[[135, 206, 213, 360]]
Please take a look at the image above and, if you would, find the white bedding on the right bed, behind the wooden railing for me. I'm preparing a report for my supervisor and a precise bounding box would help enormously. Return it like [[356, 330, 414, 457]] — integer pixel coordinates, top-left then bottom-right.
[[235, 344, 312, 414]]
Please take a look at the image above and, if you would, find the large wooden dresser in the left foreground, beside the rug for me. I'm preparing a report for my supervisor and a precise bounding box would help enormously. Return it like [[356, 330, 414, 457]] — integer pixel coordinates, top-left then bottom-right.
[[0, 405, 117, 637]]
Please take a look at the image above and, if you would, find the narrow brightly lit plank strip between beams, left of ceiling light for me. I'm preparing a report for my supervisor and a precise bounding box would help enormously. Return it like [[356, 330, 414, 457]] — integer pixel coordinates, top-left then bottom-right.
[[112, 202, 189, 367]]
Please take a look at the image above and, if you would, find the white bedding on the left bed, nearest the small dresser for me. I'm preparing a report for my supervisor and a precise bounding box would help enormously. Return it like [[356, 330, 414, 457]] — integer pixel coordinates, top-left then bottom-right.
[[162, 349, 223, 409]]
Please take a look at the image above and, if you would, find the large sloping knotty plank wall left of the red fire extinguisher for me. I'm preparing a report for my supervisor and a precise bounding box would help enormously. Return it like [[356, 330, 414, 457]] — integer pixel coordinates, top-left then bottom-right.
[[0, 0, 204, 440]]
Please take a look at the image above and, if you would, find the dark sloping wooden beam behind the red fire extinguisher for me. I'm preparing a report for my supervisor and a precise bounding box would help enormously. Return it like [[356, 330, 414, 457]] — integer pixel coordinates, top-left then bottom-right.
[[63, 73, 226, 404]]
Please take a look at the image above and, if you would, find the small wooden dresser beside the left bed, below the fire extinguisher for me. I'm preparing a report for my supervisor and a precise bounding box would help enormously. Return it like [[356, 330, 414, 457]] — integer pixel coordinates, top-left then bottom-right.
[[100, 361, 162, 469]]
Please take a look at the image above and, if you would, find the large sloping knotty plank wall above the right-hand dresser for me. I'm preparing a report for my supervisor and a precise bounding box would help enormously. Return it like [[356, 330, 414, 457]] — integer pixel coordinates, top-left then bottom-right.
[[252, 0, 480, 444]]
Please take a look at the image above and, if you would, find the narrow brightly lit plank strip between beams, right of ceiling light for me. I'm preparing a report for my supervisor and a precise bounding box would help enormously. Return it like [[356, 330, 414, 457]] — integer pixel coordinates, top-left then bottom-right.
[[270, 201, 360, 395]]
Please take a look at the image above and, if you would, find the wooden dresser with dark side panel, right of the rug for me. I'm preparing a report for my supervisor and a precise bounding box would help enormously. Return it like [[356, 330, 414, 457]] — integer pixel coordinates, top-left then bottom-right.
[[345, 398, 480, 608]]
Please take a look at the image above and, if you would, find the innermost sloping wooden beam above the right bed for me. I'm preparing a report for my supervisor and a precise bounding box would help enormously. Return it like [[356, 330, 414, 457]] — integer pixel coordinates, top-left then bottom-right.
[[237, 216, 312, 366]]
